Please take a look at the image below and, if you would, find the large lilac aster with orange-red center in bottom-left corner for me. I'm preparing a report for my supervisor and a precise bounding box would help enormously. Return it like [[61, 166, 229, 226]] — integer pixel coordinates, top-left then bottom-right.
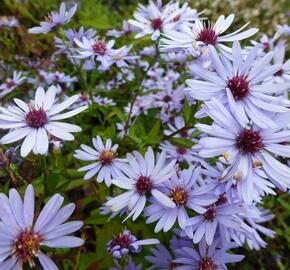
[[0, 185, 84, 270]]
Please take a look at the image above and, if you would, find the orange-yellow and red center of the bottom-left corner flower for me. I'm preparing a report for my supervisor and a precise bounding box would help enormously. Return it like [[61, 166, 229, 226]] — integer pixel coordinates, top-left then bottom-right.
[[13, 229, 42, 267]]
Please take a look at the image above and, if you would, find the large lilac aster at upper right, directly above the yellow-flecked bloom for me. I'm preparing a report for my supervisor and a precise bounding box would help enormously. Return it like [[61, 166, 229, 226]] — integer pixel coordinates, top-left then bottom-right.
[[186, 42, 290, 128]]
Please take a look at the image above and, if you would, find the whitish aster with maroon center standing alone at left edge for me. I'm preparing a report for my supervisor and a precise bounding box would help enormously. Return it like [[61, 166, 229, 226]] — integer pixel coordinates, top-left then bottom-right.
[[0, 86, 87, 157]]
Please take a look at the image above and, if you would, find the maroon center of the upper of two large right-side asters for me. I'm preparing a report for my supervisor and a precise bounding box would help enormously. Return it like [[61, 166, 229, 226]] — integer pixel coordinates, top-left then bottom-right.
[[227, 75, 249, 100]]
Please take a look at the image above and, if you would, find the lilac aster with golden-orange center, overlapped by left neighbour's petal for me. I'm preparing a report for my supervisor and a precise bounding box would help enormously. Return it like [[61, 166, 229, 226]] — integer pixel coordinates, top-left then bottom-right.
[[144, 166, 216, 232]]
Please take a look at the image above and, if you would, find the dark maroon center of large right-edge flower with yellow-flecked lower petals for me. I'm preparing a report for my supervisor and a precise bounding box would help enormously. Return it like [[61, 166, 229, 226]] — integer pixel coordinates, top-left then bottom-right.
[[236, 129, 264, 154]]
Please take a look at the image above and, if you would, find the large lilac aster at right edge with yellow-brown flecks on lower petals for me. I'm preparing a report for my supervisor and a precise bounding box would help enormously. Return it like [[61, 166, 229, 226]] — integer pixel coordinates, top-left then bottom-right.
[[196, 99, 290, 203]]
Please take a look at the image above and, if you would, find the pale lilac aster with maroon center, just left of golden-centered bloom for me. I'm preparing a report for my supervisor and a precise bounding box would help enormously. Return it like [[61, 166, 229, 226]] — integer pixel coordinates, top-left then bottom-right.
[[106, 147, 176, 220]]
